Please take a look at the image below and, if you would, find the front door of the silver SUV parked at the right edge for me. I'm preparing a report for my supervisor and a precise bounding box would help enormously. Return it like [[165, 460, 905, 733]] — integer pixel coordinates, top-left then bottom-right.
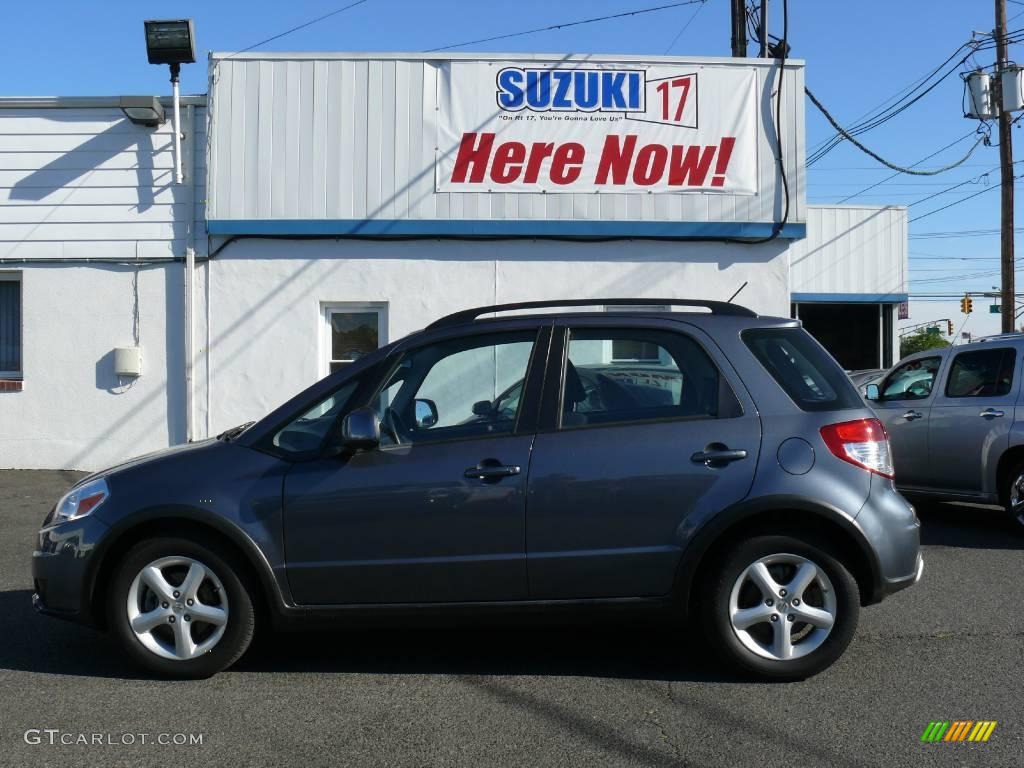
[[870, 355, 942, 487]]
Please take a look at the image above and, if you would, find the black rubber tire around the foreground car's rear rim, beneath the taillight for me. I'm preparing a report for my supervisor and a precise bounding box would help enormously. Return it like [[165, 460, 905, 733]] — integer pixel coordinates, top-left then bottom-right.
[[697, 536, 860, 681]]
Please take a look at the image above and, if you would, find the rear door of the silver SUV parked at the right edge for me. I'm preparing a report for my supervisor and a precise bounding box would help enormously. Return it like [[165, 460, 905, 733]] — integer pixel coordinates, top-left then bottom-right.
[[929, 345, 1020, 494]]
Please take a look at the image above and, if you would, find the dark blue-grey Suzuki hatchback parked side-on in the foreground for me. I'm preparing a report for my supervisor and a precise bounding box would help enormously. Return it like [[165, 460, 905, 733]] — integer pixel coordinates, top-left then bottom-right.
[[33, 299, 923, 679]]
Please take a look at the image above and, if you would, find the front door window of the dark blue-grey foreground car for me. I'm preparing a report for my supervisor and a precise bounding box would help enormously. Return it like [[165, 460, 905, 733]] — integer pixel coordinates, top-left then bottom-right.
[[372, 331, 537, 445]]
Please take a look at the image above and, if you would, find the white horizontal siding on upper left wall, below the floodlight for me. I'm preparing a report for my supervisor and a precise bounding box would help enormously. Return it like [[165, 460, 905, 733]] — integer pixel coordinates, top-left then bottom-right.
[[0, 106, 206, 259]]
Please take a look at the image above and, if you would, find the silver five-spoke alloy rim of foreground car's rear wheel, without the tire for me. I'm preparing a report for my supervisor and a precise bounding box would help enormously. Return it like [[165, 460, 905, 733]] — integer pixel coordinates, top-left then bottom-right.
[[729, 553, 837, 662]]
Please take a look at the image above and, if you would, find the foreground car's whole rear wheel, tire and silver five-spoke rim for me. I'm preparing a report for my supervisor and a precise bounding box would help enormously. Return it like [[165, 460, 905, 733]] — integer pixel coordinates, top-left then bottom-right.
[[699, 536, 860, 680]]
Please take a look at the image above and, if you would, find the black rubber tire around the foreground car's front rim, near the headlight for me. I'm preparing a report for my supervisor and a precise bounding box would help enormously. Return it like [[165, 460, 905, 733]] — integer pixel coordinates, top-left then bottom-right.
[[106, 538, 256, 679]]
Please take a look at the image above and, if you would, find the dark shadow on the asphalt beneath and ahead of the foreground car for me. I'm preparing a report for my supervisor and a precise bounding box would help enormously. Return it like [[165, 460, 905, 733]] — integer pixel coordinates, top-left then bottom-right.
[[0, 590, 743, 682]]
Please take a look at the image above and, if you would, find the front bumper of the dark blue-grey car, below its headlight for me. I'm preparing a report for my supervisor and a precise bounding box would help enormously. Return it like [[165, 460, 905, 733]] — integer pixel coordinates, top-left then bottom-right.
[[32, 515, 108, 624]]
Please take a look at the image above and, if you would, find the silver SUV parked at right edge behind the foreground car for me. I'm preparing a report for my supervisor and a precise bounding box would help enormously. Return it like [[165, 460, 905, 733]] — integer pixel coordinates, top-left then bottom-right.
[[866, 334, 1024, 531]]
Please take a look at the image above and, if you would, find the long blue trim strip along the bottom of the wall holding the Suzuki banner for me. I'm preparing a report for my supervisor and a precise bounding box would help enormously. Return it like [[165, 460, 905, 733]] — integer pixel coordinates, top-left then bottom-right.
[[207, 219, 807, 240]]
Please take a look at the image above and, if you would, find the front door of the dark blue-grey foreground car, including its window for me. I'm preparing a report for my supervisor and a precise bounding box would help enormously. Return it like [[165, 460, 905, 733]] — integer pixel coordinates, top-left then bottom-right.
[[284, 327, 550, 604]]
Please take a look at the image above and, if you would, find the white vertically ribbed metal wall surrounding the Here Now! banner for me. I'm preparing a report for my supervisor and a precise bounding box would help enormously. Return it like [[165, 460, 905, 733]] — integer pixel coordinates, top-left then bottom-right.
[[207, 53, 805, 223]]
